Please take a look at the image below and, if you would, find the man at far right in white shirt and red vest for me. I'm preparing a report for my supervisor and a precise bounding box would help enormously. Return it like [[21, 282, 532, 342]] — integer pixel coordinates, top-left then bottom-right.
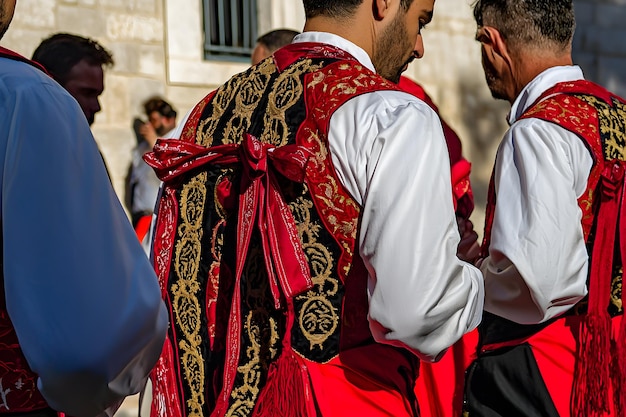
[[466, 0, 626, 417]]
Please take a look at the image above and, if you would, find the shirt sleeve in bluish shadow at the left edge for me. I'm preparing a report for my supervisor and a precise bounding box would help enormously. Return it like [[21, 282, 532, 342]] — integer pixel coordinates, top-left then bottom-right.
[[0, 62, 167, 417]]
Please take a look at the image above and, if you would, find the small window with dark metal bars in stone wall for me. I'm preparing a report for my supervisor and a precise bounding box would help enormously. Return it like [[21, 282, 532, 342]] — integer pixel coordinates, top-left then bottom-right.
[[202, 0, 258, 61]]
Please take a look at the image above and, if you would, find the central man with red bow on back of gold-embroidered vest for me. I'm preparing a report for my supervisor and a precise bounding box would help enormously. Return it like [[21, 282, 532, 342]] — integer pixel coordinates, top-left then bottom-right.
[[141, 0, 483, 416]]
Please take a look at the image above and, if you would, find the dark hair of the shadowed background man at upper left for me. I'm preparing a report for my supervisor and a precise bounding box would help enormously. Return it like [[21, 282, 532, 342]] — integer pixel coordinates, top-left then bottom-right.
[[32, 33, 114, 85]]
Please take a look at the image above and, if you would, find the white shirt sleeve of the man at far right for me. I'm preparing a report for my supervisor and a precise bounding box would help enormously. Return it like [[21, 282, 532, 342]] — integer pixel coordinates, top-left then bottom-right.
[[481, 119, 593, 324]]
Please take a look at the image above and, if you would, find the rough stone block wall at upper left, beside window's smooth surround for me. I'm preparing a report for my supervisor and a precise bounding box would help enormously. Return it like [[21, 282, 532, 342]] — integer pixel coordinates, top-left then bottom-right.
[[2, 0, 172, 202]]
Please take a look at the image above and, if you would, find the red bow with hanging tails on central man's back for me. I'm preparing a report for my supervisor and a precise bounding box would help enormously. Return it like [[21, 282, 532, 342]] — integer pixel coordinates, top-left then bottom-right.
[[144, 133, 313, 308]]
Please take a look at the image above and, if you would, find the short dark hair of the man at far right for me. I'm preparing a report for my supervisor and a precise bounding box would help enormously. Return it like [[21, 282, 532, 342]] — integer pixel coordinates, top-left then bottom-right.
[[474, 0, 576, 48]]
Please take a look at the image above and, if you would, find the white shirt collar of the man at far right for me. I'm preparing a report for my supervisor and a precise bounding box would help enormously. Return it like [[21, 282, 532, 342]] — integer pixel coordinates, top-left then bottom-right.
[[507, 65, 585, 125]]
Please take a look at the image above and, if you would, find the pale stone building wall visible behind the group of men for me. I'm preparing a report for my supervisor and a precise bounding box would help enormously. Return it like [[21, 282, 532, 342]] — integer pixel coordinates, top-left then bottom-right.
[[2, 0, 626, 229]]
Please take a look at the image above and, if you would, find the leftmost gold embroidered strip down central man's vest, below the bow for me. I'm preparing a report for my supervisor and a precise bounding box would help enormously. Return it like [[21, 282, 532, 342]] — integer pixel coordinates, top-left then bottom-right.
[[171, 172, 207, 417]]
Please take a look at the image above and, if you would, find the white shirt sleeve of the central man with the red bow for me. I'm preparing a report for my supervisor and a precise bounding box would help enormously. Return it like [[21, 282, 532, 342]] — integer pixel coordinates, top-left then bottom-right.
[[329, 91, 483, 361]]
